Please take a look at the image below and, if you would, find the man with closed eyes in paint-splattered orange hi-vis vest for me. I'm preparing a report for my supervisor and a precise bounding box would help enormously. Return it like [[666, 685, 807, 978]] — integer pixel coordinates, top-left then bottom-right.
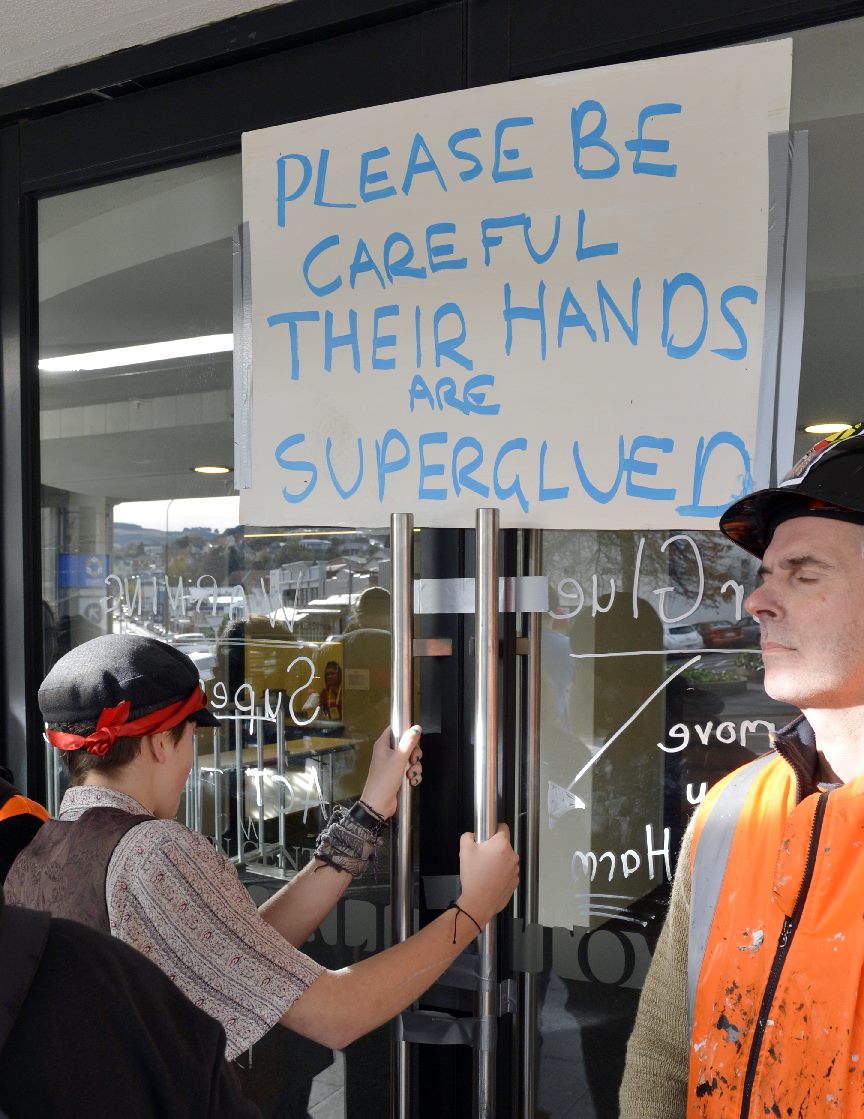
[[620, 423, 864, 1119]]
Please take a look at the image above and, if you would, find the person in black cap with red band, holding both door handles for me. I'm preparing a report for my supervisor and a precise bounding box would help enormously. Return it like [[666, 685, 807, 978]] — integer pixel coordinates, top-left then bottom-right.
[[6, 634, 518, 1057]]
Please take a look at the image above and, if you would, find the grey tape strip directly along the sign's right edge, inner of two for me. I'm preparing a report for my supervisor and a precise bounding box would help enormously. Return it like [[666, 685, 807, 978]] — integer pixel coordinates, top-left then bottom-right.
[[753, 132, 790, 489]]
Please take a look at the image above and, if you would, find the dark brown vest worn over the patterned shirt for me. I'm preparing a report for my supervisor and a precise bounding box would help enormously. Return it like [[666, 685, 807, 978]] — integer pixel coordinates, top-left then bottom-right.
[[3, 808, 152, 933]]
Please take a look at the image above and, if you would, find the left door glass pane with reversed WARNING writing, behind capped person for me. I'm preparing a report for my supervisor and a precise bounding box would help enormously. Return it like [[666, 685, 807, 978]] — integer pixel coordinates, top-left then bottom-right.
[[38, 156, 400, 1117]]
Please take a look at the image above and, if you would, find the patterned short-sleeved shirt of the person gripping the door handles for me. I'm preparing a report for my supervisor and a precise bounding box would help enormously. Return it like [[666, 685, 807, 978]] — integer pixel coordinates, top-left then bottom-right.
[[59, 786, 323, 1059]]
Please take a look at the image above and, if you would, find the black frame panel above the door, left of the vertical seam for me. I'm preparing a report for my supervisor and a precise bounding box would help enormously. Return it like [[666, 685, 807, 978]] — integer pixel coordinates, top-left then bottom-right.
[[21, 4, 463, 192]]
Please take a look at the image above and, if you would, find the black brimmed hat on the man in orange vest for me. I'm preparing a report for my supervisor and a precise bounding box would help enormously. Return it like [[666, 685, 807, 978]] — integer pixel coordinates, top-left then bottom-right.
[[720, 422, 864, 560]]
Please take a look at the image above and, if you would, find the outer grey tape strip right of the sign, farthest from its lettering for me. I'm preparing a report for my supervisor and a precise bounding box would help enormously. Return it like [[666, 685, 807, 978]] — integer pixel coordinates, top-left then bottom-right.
[[774, 132, 810, 478]]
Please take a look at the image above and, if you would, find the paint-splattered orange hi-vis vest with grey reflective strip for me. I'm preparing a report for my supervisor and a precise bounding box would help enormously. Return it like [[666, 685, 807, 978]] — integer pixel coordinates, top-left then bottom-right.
[[687, 754, 864, 1119]]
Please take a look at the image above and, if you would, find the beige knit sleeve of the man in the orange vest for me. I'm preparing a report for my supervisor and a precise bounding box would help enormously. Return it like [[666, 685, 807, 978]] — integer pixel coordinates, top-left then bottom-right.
[[620, 817, 695, 1119]]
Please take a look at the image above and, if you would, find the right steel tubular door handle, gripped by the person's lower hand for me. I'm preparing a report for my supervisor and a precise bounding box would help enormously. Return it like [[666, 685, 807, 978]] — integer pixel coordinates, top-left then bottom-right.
[[473, 509, 498, 1119]]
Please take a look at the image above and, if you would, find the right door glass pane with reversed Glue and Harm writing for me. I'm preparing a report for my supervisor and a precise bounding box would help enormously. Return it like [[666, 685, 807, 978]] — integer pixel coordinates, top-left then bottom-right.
[[523, 532, 792, 1117]]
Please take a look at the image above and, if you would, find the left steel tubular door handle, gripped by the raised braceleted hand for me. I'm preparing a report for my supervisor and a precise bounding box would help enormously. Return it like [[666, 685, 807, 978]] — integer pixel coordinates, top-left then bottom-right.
[[389, 513, 414, 1119]]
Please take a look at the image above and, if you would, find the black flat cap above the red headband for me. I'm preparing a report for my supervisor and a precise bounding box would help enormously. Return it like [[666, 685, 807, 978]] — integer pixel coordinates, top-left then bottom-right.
[[39, 633, 219, 726]]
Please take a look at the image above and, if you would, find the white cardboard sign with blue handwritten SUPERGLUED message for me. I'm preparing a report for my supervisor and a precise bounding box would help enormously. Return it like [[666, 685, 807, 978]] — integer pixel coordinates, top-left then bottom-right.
[[241, 40, 791, 528]]
